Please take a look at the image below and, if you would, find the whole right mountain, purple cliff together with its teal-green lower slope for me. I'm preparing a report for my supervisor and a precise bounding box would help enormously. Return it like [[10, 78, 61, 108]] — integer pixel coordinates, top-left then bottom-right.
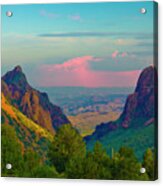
[[85, 66, 157, 158]]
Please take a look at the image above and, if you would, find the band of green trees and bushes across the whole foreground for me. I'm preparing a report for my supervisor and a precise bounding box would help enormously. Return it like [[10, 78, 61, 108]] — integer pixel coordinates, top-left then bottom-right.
[[2, 125, 155, 180]]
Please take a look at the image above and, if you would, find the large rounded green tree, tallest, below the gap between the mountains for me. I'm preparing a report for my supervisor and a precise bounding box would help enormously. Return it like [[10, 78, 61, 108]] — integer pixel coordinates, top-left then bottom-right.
[[48, 125, 86, 173]]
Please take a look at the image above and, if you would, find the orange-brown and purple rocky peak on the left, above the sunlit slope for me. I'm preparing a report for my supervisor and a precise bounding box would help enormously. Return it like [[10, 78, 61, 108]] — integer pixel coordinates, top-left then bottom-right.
[[1, 66, 70, 133]]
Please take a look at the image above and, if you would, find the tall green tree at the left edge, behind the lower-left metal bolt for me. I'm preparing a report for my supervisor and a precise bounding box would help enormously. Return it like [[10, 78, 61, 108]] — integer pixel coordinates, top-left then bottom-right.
[[1, 124, 23, 177]]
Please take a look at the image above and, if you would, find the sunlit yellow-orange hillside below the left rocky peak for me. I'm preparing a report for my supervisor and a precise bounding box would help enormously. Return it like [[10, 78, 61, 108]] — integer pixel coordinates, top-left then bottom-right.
[[1, 93, 53, 158]]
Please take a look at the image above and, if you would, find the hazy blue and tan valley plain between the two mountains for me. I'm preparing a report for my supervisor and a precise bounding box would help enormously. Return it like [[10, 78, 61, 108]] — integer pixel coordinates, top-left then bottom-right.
[[39, 87, 130, 136]]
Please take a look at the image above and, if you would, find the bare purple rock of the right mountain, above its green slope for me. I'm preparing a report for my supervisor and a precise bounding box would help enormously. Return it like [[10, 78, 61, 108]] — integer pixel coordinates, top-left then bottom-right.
[[85, 66, 157, 141]]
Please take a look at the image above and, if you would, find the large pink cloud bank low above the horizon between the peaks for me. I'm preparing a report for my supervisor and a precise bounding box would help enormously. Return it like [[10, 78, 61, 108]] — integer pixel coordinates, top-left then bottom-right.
[[39, 56, 140, 87]]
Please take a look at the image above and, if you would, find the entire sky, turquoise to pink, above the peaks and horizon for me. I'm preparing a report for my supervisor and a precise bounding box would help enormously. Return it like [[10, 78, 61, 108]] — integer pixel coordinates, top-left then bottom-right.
[[1, 2, 154, 88]]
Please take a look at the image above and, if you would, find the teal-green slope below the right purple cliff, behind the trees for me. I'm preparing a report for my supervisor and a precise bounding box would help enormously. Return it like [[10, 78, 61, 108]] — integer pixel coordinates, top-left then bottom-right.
[[87, 124, 155, 160]]
